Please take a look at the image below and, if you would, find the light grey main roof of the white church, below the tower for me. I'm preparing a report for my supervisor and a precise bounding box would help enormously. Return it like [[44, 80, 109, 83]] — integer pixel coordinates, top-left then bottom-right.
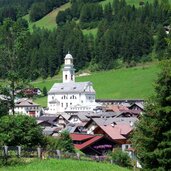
[[48, 82, 95, 94]]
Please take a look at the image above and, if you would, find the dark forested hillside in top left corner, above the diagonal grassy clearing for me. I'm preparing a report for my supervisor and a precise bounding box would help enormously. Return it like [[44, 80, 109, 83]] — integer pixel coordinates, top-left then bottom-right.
[[0, 0, 69, 22]]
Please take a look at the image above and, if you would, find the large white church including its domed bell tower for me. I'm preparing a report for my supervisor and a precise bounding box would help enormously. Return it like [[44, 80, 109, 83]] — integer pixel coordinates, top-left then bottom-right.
[[48, 53, 99, 114]]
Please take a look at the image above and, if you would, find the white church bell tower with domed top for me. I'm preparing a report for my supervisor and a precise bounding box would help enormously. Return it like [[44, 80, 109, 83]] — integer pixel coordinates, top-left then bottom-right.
[[63, 53, 75, 83]]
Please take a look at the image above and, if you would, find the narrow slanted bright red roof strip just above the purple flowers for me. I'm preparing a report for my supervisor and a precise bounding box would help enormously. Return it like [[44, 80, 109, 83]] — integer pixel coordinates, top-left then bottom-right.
[[74, 135, 103, 150]]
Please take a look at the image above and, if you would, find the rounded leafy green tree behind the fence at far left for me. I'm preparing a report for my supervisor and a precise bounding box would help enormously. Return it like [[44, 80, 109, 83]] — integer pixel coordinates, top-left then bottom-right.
[[0, 115, 45, 147]]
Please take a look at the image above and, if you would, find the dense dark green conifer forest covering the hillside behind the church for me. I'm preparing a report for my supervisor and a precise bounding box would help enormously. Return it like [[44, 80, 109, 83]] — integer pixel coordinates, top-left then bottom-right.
[[0, 0, 171, 80]]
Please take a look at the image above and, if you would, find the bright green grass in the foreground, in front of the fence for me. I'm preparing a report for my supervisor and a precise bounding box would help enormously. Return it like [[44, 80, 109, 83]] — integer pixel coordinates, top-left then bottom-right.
[[0, 159, 129, 171]]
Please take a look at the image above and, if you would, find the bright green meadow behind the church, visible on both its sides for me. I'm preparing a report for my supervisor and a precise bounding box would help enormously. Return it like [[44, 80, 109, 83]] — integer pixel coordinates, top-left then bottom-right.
[[32, 63, 160, 106]]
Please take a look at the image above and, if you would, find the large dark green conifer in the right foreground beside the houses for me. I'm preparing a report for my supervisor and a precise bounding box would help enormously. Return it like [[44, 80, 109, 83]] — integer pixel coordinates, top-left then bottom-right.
[[132, 60, 171, 171]]
